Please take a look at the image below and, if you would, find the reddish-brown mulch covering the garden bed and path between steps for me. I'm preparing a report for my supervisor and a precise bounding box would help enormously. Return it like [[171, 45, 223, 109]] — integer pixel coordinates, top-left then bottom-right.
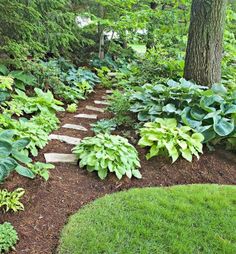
[[0, 88, 236, 254]]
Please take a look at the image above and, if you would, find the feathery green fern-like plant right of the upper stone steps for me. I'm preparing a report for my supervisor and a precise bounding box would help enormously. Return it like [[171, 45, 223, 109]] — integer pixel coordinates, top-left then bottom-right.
[[108, 90, 133, 125]]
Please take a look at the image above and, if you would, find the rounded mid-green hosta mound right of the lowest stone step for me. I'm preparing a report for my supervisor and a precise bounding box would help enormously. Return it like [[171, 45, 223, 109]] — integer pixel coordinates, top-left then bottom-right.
[[73, 134, 141, 179]]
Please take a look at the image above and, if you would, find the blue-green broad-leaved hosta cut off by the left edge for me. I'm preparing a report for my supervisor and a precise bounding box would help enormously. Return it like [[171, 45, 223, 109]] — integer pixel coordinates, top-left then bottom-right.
[[0, 130, 34, 181]]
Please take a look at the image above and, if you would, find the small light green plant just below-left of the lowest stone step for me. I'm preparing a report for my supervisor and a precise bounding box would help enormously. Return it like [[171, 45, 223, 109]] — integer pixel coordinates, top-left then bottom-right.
[[27, 162, 55, 181]]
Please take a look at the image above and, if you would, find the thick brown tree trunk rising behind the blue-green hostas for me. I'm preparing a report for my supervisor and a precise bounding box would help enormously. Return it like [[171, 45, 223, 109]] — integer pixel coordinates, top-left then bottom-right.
[[184, 0, 227, 86]]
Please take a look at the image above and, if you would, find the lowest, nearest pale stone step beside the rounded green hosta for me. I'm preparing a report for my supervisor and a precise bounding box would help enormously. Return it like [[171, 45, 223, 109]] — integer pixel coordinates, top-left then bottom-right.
[[44, 153, 78, 165]]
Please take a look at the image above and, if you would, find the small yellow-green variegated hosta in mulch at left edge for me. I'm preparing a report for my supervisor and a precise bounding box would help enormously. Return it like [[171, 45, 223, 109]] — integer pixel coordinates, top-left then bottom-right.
[[0, 188, 25, 212]]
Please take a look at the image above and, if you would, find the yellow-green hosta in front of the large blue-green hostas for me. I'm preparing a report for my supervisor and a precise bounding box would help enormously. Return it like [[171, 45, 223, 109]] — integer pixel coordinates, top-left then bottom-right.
[[139, 118, 204, 162]]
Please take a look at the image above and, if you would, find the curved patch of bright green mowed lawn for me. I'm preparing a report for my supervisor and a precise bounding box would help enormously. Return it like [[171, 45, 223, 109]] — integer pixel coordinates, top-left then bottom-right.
[[59, 185, 236, 254]]
